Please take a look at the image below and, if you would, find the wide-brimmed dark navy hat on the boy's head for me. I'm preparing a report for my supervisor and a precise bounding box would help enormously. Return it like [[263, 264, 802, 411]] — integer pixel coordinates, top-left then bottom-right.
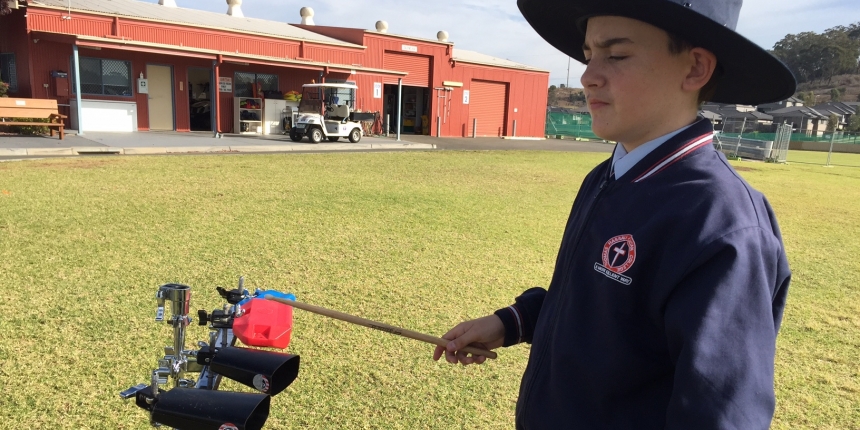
[[517, 0, 797, 105]]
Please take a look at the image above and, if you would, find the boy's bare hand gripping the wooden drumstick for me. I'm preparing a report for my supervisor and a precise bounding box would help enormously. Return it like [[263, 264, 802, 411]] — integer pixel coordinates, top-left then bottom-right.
[[433, 315, 505, 366]]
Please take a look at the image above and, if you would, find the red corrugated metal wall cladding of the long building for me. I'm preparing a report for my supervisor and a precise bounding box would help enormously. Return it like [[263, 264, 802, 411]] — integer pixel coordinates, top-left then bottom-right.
[[20, 7, 549, 136]]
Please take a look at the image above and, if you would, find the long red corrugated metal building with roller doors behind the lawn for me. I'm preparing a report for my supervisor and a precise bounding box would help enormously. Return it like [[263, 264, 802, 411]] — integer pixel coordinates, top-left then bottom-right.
[[0, 0, 549, 137]]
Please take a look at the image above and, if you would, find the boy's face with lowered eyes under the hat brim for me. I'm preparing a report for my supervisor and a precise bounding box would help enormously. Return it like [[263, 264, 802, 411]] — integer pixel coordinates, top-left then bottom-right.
[[581, 16, 697, 147]]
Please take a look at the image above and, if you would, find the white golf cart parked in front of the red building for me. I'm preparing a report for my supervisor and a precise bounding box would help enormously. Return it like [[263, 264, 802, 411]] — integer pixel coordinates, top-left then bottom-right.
[[290, 83, 363, 143]]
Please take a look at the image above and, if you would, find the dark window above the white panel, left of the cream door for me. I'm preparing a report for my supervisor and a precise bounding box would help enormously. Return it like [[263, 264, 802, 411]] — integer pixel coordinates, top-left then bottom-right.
[[71, 57, 134, 97]]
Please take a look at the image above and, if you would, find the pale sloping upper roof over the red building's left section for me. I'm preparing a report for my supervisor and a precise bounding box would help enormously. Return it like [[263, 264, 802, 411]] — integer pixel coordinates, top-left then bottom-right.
[[28, 0, 363, 48]]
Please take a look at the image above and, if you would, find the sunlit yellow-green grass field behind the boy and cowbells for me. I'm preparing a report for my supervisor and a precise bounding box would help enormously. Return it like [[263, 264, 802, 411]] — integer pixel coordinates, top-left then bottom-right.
[[0, 151, 860, 429]]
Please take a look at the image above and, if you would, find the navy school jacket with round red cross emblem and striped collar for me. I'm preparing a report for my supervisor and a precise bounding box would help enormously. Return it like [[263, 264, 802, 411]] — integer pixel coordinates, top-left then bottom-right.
[[496, 120, 790, 430]]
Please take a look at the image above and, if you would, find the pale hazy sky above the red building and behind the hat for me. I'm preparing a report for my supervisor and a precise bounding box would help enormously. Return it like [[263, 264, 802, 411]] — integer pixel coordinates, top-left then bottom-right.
[[145, 0, 860, 87]]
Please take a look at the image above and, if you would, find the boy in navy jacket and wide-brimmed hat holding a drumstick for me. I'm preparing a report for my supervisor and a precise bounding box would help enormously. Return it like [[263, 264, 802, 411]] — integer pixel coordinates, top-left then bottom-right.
[[434, 0, 795, 430]]
